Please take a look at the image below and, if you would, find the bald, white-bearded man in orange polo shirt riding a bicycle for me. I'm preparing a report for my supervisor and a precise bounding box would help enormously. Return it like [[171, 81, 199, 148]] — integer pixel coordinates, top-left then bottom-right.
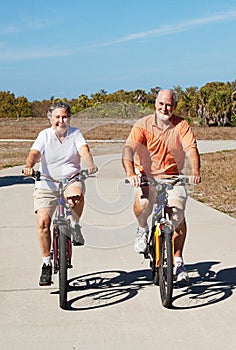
[[122, 90, 201, 281]]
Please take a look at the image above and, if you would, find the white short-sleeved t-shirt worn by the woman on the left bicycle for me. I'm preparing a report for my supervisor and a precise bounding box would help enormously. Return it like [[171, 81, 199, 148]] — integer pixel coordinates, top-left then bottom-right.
[[31, 127, 87, 190]]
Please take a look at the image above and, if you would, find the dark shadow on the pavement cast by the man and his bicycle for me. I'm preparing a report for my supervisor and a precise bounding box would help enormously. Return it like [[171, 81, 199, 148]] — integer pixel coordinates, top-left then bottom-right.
[[173, 261, 236, 310]]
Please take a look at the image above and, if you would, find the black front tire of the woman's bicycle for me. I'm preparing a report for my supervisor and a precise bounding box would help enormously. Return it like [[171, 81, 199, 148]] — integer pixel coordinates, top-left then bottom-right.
[[58, 225, 67, 310]]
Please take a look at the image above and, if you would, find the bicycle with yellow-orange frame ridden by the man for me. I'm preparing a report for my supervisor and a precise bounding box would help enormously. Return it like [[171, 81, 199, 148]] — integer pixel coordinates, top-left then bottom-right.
[[126, 176, 189, 308]]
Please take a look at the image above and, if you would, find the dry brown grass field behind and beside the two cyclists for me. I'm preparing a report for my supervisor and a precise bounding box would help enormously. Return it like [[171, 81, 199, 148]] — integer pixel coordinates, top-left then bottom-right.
[[0, 118, 236, 218]]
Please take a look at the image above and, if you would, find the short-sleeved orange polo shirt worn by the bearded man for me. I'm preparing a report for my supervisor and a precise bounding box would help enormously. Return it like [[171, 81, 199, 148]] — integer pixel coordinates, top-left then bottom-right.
[[126, 114, 197, 176]]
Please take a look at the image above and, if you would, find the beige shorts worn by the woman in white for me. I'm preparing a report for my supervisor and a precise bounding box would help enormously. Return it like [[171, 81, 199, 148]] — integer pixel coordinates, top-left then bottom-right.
[[33, 181, 85, 215]]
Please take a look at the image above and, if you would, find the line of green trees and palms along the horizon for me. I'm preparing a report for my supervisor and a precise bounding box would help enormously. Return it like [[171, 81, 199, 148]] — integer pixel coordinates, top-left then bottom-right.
[[0, 79, 236, 126]]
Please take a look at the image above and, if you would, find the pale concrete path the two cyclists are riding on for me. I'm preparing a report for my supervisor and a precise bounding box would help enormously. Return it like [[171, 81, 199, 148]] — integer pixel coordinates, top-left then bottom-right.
[[0, 141, 236, 350]]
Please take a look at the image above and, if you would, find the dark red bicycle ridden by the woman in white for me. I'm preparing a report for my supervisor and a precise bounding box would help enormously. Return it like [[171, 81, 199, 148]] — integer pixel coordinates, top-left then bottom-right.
[[24, 170, 89, 310]]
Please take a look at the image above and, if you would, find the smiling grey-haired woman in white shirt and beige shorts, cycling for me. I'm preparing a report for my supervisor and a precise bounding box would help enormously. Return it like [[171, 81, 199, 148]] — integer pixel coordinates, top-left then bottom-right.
[[23, 102, 97, 286]]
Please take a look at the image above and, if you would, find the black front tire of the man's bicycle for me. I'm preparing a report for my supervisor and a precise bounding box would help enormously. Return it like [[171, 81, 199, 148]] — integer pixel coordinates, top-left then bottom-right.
[[159, 226, 173, 308]]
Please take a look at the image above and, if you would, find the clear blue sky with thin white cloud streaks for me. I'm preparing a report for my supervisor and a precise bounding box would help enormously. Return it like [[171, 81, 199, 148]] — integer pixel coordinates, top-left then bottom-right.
[[0, 0, 236, 101]]
